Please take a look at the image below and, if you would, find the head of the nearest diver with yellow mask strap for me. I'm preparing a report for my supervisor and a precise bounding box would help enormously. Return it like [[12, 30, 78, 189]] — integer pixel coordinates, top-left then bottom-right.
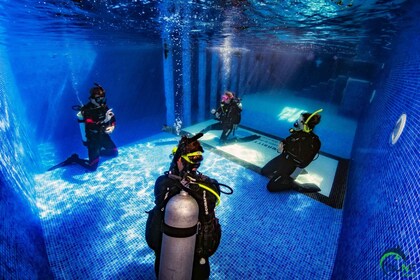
[[170, 134, 204, 174]]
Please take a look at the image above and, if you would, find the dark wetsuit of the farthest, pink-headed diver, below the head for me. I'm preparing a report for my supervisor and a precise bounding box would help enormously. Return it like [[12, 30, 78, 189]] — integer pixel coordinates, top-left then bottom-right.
[[201, 98, 242, 143]]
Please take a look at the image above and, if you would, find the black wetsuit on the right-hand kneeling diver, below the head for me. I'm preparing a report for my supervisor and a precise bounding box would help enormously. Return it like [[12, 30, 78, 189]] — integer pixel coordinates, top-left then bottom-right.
[[261, 130, 321, 192]]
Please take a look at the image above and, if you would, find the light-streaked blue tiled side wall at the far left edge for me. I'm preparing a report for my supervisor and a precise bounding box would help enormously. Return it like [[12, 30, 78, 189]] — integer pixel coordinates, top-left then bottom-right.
[[0, 32, 52, 279]]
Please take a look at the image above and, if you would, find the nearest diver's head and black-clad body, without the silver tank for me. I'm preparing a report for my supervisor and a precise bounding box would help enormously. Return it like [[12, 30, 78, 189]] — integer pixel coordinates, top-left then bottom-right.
[[146, 133, 233, 279]]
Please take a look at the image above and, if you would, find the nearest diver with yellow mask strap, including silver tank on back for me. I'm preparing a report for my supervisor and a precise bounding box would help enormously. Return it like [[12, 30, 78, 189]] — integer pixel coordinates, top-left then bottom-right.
[[146, 133, 232, 279]]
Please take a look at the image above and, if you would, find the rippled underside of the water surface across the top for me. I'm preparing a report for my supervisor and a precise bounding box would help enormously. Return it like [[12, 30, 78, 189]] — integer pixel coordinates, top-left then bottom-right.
[[0, 0, 406, 60]]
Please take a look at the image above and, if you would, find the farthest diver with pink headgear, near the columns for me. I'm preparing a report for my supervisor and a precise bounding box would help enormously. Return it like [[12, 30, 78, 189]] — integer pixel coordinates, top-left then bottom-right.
[[201, 91, 242, 144]]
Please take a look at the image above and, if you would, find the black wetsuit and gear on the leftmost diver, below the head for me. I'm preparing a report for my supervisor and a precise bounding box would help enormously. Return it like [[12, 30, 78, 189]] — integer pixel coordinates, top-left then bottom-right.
[[81, 102, 118, 170]]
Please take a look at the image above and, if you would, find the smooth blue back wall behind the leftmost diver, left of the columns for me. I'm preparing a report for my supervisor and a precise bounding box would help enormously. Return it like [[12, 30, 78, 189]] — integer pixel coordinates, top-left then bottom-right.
[[9, 43, 166, 152]]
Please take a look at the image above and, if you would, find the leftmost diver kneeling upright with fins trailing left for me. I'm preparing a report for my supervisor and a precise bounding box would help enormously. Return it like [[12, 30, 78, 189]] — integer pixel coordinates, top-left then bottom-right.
[[48, 83, 118, 171]]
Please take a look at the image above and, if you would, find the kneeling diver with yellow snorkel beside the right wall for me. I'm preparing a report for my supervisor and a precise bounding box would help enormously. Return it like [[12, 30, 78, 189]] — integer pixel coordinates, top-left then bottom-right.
[[261, 109, 322, 192]]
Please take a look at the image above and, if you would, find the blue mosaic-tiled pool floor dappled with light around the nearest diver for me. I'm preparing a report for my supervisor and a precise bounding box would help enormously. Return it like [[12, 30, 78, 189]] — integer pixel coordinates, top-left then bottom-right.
[[36, 133, 342, 280]]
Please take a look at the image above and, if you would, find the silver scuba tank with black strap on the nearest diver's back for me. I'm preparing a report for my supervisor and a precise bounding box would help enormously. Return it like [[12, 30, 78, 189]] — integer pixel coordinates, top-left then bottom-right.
[[159, 190, 199, 280]]
